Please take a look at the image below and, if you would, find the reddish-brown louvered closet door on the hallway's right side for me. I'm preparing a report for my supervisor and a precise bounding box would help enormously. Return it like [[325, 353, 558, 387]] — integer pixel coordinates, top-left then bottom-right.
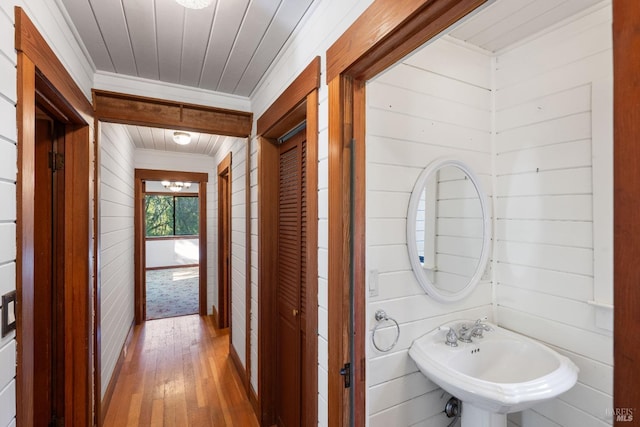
[[276, 131, 306, 427]]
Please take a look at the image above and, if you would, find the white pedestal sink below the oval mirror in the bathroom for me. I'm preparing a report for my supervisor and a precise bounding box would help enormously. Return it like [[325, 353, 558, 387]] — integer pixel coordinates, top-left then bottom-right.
[[409, 320, 578, 427]]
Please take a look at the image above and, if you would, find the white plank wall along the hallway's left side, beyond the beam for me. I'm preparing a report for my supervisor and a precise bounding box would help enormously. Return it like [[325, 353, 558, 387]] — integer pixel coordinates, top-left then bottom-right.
[[100, 123, 135, 397]]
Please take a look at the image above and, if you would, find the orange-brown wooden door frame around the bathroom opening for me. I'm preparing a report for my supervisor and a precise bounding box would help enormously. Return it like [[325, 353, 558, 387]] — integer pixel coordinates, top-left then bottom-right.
[[327, 0, 640, 426]]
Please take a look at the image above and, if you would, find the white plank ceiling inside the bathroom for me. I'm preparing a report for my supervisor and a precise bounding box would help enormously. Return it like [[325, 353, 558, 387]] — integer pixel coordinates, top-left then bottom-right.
[[449, 0, 602, 52]]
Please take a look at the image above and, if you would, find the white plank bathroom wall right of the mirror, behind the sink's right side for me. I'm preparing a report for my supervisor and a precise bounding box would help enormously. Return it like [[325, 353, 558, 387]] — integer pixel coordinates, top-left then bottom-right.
[[495, 4, 613, 427]]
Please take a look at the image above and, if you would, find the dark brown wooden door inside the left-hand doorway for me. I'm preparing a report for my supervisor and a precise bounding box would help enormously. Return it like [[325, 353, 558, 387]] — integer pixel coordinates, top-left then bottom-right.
[[33, 111, 65, 426]]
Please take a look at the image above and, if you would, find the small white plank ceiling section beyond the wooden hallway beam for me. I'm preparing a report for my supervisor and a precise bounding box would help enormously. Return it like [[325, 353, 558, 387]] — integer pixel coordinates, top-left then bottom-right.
[[125, 125, 244, 156]]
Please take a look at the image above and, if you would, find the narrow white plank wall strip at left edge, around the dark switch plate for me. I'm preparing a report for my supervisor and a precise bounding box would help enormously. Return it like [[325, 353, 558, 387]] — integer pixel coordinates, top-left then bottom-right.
[[0, 8, 17, 426]]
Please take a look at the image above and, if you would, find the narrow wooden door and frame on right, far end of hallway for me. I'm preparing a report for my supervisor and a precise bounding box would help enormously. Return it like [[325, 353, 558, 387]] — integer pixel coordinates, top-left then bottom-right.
[[218, 153, 231, 329]]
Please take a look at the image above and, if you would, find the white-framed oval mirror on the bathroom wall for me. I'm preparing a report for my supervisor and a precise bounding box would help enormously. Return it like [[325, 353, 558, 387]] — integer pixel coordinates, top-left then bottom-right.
[[407, 159, 491, 302]]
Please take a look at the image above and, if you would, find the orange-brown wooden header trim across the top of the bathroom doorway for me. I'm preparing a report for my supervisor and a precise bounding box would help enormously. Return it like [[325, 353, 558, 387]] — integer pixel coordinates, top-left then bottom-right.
[[327, 0, 487, 83]]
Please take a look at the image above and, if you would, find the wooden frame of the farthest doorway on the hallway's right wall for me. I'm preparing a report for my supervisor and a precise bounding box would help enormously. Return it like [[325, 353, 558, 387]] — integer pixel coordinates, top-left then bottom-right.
[[214, 153, 232, 329]]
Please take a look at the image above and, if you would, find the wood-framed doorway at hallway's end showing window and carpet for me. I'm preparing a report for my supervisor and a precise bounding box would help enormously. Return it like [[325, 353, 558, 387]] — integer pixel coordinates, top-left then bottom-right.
[[134, 169, 208, 324]]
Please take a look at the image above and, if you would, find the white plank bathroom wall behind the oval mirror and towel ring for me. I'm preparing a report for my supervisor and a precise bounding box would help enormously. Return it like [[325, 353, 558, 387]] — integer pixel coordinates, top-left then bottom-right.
[[366, 39, 492, 427]]
